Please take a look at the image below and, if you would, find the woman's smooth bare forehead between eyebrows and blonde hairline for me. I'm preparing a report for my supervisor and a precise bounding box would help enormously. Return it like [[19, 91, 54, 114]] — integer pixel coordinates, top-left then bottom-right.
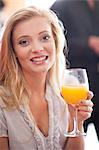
[[13, 16, 51, 36]]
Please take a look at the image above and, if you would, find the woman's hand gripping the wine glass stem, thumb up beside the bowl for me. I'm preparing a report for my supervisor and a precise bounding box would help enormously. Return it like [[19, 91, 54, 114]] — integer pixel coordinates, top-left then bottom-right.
[[69, 91, 93, 130]]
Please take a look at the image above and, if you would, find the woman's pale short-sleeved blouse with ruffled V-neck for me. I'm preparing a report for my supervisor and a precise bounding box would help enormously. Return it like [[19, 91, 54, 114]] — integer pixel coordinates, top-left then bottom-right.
[[0, 86, 68, 150]]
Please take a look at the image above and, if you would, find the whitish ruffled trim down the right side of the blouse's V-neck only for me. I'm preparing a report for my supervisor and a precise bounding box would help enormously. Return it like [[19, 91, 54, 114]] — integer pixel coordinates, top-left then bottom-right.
[[47, 86, 61, 150]]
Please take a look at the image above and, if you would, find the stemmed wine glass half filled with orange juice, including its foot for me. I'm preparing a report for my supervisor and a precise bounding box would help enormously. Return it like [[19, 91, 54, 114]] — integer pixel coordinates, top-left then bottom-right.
[[61, 68, 89, 137]]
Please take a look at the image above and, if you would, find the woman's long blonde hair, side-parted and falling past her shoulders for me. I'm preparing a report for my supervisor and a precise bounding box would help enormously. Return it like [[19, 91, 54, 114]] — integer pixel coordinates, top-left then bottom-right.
[[0, 7, 65, 107]]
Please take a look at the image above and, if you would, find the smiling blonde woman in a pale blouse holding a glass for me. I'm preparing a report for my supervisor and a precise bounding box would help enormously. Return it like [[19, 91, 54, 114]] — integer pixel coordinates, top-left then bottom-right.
[[0, 7, 93, 150]]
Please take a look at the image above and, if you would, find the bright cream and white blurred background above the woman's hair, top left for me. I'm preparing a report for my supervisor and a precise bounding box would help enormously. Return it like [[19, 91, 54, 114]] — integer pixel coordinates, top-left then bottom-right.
[[0, 0, 55, 34]]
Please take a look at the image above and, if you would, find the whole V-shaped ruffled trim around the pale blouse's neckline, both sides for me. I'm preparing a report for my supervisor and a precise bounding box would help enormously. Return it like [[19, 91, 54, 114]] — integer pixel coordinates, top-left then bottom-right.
[[20, 84, 62, 150]]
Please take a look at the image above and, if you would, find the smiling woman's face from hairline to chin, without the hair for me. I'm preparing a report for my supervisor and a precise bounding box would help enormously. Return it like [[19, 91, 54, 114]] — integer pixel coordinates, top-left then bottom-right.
[[12, 17, 56, 73]]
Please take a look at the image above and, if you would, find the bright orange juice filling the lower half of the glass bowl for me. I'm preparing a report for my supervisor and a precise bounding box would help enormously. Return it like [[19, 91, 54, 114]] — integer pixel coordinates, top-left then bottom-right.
[[61, 86, 88, 104]]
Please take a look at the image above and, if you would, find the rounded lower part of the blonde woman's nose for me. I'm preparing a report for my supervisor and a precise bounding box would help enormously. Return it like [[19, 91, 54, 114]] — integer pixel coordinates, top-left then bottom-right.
[[32, 41, 43, 53]]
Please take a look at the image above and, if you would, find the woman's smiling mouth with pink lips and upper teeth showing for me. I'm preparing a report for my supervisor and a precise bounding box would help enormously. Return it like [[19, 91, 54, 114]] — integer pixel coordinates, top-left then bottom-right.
[[30, 56, 48, 64]]
